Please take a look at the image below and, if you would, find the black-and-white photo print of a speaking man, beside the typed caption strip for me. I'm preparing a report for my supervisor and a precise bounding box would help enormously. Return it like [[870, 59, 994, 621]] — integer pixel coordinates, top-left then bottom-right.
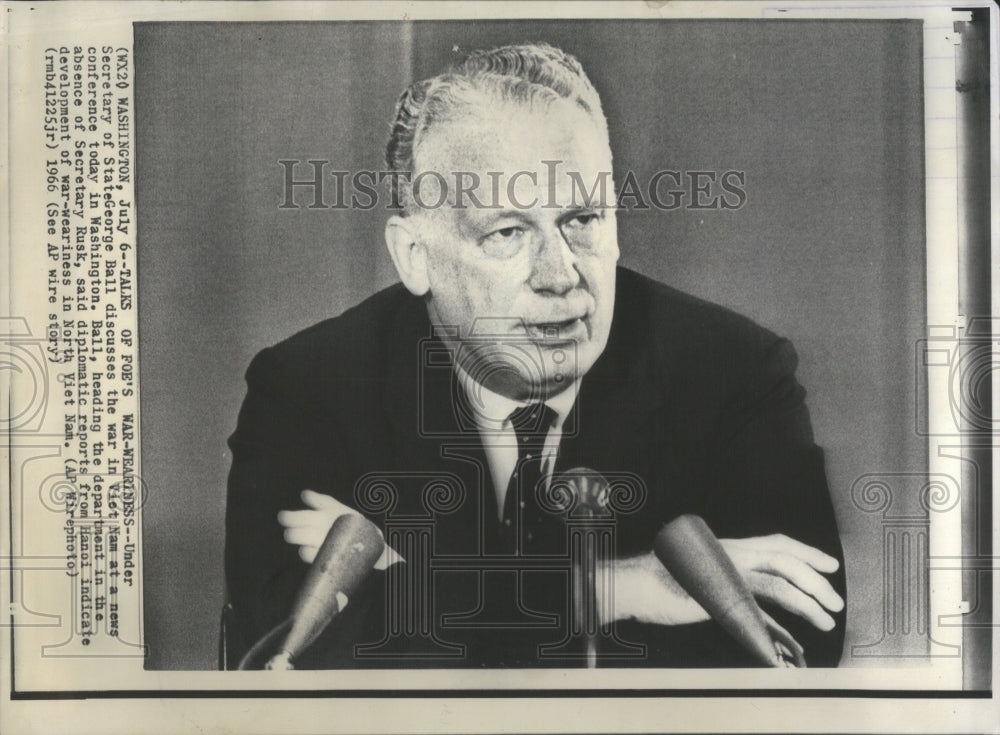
[[136, 15, 950, 668]]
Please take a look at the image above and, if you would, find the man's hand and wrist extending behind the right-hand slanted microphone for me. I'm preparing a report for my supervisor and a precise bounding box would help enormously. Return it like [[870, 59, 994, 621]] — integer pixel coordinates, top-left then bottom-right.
[[598, 534, 844, 631]]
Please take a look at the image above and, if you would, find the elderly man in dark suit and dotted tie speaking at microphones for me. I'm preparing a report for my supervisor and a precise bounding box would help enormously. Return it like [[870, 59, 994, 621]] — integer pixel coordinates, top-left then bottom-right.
[[226, 45, 844, 668]]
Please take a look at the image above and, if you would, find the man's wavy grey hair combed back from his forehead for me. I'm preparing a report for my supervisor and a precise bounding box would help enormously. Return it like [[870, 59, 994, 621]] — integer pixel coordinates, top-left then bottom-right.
[[385, 43, 608, 206]]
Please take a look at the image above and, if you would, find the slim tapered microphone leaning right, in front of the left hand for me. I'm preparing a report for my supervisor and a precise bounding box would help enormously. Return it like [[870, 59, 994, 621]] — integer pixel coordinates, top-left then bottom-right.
[[265, 513, 385, 669]]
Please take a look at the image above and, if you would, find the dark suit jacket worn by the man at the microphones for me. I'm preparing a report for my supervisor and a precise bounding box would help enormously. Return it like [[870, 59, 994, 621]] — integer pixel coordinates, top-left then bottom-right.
[[226, 268, 845, 667]]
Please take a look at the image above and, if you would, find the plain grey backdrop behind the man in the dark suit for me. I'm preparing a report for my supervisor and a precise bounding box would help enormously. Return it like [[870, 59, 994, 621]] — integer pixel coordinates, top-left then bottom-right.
[[135, 20, 927, 669]]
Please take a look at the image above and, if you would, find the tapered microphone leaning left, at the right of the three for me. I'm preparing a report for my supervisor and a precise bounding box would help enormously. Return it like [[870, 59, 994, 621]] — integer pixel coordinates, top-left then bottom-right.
[[653, 514, 805, 667]]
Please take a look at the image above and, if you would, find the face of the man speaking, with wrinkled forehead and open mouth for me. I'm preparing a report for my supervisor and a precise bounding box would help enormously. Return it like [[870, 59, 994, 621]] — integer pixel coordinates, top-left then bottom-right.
[[406, 102, 618, 399]]
